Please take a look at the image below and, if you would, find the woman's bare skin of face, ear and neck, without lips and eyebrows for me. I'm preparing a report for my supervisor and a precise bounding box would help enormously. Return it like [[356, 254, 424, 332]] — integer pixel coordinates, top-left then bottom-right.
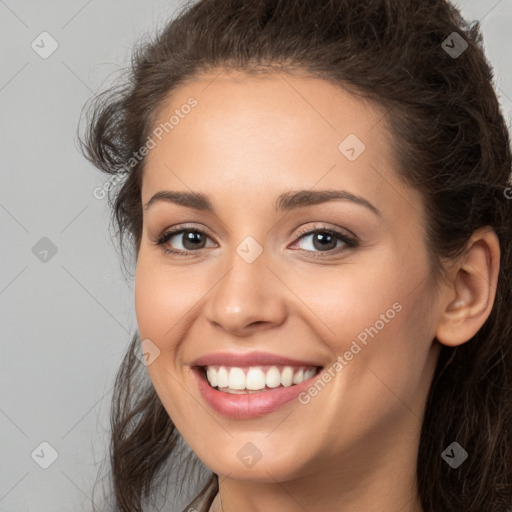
[[135, 70, 499, 512]]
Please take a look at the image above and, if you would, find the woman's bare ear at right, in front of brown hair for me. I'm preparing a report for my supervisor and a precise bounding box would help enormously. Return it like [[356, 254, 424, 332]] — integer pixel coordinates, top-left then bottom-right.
[[436, 227, 500, 347]]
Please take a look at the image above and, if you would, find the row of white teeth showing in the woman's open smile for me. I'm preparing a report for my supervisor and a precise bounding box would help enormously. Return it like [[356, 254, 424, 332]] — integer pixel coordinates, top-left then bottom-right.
[[202, 366, 317, 393]]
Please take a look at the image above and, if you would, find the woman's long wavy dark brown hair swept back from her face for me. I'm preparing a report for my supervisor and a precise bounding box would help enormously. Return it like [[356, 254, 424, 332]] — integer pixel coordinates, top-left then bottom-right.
[[81, 0, 512, 512]]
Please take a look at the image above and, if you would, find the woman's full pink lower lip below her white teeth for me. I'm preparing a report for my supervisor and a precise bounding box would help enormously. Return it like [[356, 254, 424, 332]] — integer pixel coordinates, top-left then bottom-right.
[[193, 367, 320, 419]]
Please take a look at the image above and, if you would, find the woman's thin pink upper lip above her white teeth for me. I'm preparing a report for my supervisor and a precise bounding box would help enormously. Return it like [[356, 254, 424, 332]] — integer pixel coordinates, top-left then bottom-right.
[[191, 352, 322, 367]]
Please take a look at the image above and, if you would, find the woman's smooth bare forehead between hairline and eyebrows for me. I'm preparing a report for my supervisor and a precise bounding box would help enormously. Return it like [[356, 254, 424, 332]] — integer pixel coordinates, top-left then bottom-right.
[[142, 68, 416, 220]]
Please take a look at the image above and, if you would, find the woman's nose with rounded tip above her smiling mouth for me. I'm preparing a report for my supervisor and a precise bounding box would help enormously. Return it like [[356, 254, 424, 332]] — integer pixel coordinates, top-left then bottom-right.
[[205, 247, 290, 337]]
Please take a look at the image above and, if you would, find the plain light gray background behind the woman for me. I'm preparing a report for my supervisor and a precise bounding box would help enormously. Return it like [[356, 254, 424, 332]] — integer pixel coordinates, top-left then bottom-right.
[[0, 0, 512, 512]]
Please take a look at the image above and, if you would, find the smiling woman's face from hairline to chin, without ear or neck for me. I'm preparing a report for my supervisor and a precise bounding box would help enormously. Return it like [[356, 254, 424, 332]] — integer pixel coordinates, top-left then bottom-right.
[[135, 73, 438, 482]]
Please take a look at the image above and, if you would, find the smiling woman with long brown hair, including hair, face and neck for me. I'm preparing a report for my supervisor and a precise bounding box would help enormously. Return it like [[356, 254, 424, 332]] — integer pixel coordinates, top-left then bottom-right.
[[78, 0, 512, 512]]
